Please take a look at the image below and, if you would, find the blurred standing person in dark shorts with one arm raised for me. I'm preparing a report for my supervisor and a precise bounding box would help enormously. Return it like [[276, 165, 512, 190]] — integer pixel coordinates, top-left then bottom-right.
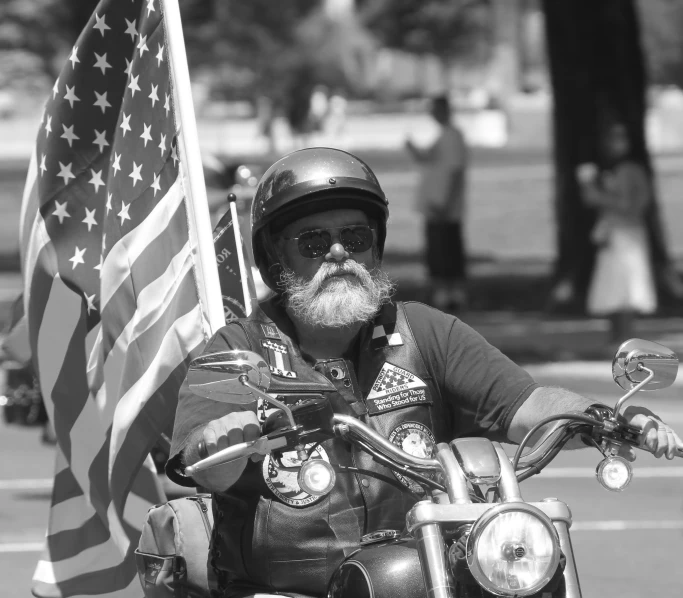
[[405, 95, 468, 310]]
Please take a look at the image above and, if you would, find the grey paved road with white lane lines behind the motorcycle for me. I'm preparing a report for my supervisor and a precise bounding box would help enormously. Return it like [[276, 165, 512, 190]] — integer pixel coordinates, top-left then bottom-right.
[[0, 362, 683, 598]]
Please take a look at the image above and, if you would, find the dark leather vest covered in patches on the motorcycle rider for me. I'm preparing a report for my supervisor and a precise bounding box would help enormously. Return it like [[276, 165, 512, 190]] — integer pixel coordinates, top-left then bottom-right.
[[212, 303, 451, 595]]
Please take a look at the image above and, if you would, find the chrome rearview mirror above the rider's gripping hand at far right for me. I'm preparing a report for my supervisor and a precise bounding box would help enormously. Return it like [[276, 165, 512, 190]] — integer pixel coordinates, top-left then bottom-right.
[[612, 338, 678, 391]]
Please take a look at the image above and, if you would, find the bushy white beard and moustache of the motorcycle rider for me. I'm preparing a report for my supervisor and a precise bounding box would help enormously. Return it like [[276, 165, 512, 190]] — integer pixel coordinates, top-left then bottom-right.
[[280, 260, 394, 328]]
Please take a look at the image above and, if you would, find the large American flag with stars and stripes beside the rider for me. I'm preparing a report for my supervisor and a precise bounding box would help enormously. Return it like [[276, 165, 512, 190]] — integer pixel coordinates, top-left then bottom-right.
[[21, 0, 230, 597]]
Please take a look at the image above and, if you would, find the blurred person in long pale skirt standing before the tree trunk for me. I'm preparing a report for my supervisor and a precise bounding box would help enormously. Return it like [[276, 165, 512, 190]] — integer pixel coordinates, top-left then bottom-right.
[[577, 124, 657, 343]]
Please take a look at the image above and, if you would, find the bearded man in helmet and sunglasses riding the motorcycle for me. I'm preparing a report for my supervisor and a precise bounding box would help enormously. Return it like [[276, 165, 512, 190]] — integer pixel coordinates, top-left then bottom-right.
[[166, 148, 683, 598]]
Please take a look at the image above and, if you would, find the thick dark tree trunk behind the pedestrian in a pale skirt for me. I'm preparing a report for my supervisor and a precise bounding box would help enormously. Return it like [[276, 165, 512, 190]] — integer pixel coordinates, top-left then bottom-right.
[[543, 0, 670, 308]]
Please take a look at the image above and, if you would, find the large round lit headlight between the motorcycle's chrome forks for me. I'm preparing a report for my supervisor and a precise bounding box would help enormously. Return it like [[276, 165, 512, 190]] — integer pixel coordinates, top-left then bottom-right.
[[467, 503, 560, 596]]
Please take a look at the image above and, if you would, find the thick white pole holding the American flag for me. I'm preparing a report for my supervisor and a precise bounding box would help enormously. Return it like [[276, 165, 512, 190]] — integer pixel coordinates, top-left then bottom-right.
[[162, 0, 225, 334]]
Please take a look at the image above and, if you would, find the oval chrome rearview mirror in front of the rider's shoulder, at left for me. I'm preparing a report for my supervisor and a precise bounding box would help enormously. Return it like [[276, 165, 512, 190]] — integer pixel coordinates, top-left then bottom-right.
[[187, 350, 270, 405]]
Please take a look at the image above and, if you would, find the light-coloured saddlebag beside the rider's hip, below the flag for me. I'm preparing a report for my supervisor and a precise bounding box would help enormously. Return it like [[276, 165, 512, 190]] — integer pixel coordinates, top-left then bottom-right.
[[135, 494, 216, 598]]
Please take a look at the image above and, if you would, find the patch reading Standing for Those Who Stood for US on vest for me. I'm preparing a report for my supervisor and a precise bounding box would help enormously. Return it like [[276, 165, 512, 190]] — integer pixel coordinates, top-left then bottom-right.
[[365, 362, 432, 415]]
